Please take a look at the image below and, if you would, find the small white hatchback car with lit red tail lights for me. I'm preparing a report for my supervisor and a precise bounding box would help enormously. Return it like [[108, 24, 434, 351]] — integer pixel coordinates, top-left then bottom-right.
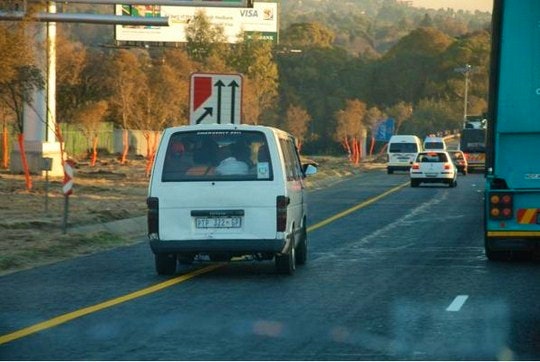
[[410, 150, 458, 187]]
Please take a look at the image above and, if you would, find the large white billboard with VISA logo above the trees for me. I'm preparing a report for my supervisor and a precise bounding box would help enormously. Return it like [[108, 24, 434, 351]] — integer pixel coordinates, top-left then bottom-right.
[[116, 2, 278, 43]]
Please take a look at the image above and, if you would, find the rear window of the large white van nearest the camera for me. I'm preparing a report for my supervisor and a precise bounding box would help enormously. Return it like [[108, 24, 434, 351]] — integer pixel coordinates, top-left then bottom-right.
[[161, 130, 273, 182]]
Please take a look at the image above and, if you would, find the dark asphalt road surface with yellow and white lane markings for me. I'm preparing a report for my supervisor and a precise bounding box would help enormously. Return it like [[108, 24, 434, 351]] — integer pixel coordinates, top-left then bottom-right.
[[0, 170, 540, 360]]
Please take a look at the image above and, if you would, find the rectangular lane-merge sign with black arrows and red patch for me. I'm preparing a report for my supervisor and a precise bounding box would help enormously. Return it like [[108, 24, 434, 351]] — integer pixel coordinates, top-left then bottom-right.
[[189, 73, 242, 124]]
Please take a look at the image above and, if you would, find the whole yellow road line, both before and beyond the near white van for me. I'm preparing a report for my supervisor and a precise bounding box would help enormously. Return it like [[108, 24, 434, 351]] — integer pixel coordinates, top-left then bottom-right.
[[0, 182, 409, 345]]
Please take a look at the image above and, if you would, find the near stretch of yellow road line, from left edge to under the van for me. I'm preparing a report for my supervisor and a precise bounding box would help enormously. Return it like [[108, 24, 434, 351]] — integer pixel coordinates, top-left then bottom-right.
[[0, 263, 224, 345]]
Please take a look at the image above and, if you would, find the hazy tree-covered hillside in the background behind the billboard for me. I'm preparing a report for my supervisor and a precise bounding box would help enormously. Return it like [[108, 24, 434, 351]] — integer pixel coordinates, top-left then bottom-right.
[[58, 0, 491, 54]]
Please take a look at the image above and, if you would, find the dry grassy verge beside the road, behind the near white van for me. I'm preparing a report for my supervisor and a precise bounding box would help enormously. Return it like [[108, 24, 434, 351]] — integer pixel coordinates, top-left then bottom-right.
[[0, 156, 380, 275]]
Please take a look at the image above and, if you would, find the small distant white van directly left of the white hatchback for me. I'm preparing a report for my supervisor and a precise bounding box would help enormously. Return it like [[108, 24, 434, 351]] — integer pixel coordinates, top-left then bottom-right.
[[386, 135, 422, 174]]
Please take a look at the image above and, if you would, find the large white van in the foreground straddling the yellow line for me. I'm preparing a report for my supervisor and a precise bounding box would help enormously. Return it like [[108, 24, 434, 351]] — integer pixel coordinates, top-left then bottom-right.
[[147, 124, 316, 274]]
